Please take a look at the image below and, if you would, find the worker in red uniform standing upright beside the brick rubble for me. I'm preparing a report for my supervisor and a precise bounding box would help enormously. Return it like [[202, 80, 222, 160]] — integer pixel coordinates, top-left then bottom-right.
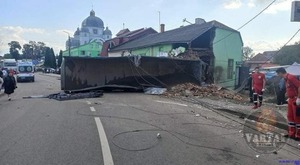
[[252, 67, 266, 109]]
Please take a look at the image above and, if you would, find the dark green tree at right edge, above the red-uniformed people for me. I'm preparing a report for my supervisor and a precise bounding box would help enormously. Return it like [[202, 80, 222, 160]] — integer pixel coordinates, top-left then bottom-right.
[[274, 44, 300, 65]]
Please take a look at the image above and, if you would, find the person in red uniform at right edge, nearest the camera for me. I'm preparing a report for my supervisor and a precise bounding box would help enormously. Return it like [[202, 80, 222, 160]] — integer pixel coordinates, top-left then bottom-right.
[[276, 68, 300, 140]]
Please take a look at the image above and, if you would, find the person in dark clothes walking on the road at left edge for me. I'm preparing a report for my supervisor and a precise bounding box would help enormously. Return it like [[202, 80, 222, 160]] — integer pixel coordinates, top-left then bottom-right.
[[3, 70, 17, 101]]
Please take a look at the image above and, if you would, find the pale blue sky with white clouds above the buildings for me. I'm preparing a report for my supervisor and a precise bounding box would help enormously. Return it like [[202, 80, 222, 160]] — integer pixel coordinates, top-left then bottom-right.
[[0, 0, 300, 56]]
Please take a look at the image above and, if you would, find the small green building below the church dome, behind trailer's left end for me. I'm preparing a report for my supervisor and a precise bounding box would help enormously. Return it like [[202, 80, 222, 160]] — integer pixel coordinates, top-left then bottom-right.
[[63, 42, 102, 57]]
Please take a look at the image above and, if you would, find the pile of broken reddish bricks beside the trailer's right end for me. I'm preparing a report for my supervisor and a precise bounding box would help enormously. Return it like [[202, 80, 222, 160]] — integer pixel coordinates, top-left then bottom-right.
[[165, 83, 243, 101]]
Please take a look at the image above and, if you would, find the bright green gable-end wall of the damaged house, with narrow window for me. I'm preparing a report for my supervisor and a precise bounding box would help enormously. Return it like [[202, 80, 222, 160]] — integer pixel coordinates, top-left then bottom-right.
[[213, 28, 243, 88]]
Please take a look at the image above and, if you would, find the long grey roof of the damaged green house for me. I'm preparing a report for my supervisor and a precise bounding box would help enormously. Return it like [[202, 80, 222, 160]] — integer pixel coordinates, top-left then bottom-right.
[[111, 21, 239, 52]]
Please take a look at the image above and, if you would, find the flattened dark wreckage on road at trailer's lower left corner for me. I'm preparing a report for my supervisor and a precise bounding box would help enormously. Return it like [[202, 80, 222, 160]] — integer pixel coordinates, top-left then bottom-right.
[[23, 91, 103, 101]]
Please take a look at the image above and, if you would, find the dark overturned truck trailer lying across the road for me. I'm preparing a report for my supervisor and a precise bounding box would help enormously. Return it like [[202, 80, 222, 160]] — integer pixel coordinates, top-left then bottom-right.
[[61, 56, 205, 91]]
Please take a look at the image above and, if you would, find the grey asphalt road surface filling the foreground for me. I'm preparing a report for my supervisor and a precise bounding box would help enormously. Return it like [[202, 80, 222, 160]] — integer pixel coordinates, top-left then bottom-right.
[[0, 73, 300, 165]]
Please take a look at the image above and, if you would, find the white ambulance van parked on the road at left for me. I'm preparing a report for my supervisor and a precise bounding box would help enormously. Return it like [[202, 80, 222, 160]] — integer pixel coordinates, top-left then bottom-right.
[[17, 62, 34, 82]]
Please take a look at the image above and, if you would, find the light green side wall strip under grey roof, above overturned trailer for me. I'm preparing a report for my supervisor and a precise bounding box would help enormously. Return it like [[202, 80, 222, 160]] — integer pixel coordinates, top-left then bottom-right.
[[131, 44, 172, 57]]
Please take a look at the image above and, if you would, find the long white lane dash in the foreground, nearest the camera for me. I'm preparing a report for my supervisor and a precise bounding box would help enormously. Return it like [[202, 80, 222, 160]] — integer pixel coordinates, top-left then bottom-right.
[[95, 117, 114, 165]]
